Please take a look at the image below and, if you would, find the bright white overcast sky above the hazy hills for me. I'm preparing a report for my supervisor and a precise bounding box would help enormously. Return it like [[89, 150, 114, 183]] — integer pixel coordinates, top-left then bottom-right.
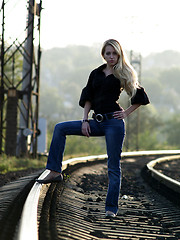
[[1, 0, 180, 56]]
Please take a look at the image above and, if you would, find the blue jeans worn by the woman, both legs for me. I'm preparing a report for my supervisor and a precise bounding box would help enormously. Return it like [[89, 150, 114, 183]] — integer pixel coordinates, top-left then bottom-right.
[[46, 118, 125, 213]]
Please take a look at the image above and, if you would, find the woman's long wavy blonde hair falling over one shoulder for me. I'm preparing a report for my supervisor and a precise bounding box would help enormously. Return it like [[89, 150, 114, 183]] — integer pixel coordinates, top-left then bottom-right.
[[101, 39, 139, 97]]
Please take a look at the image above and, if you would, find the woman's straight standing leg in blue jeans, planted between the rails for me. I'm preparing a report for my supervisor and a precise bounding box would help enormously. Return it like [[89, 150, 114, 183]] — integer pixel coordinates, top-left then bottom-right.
[[105, 119, 125, 214]]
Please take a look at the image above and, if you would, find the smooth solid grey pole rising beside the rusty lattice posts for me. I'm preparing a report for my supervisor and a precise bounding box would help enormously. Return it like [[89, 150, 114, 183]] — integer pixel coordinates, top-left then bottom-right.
[[16, 0, 34, 156]]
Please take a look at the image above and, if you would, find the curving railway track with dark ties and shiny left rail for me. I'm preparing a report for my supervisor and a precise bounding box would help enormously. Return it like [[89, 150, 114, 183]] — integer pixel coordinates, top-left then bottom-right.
[[0, 152, 180, 240]]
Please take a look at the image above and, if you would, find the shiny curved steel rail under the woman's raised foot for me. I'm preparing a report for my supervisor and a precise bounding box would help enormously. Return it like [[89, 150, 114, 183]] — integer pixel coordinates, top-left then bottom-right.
[[17, 150, 180, 240]]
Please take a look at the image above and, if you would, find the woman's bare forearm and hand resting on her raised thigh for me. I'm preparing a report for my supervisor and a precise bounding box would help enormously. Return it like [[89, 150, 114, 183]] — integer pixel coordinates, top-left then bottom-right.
[[82, 101, 91, 137]]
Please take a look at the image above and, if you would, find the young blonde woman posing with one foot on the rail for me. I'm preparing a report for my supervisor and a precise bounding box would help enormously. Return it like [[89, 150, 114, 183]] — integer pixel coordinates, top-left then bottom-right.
[[37, 39, 149, 217]]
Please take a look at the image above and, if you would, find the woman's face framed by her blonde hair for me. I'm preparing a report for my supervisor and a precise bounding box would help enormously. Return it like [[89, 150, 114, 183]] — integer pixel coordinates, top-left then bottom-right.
[[103, 45, 119, 67]]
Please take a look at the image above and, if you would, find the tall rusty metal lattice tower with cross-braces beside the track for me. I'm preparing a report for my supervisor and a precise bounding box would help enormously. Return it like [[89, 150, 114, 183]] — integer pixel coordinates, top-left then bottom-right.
[[0, 0, 42, 157]]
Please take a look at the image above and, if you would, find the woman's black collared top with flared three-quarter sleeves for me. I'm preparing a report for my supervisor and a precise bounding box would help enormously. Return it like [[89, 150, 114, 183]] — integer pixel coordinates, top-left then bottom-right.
[[79, 64, 149, 114]]
